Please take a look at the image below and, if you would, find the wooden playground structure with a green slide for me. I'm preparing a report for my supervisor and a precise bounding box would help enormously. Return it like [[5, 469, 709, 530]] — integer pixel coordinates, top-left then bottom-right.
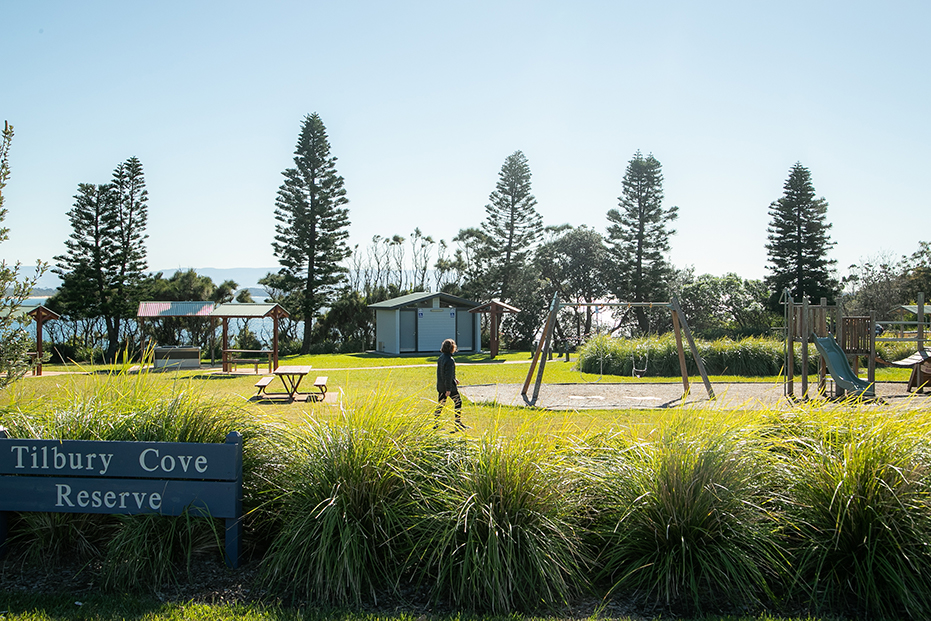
[[783, 290, 929, 399]]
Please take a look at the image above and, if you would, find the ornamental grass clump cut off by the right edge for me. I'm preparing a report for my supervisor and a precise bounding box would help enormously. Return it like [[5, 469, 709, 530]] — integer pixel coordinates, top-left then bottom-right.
[[787, 410, 931, 619]]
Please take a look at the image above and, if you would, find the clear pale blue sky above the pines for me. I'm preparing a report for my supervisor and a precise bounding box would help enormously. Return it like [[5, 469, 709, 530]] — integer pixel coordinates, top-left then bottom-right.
[[0, 0, 931, 286]]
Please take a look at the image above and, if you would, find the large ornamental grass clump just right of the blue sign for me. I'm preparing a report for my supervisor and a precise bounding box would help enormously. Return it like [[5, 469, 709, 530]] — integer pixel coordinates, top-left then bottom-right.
[[262, 395, 442, 605]]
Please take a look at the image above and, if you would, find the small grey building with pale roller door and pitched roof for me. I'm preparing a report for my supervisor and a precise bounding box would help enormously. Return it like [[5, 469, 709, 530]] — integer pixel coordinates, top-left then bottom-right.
[[369, 292, 482, 354]]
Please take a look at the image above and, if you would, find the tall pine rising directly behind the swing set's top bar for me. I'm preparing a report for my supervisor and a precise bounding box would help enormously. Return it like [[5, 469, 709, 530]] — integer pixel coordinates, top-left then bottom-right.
[[607, 150, 679, 332]]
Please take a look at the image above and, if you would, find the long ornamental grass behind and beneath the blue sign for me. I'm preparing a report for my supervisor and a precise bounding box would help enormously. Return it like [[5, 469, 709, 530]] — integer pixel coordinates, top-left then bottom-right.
[[0, 369, 278, 588]]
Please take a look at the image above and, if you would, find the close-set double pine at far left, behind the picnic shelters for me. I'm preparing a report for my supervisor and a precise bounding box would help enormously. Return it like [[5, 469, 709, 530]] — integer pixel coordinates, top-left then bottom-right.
[[49, 157, 149, 360]]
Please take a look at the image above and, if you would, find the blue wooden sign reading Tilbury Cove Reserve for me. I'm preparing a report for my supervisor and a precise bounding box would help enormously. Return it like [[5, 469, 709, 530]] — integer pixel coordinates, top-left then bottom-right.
[[0, 428, 242, 567]]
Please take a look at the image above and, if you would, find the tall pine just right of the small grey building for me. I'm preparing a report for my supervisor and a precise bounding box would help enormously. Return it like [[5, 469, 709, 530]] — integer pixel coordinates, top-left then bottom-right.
[[484, 151, 543, 301]]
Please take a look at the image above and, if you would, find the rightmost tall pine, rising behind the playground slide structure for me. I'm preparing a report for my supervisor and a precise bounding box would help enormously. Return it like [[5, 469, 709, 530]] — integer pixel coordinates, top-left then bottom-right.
[[766, 162, 838, 310]]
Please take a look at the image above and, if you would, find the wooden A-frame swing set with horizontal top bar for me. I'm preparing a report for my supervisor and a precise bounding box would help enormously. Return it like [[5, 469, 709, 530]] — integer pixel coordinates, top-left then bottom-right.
[[520, 293, 715, 405]]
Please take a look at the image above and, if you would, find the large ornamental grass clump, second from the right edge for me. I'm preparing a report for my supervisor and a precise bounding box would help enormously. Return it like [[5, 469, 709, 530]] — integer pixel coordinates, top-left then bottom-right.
[[592, 412, 781, 610]]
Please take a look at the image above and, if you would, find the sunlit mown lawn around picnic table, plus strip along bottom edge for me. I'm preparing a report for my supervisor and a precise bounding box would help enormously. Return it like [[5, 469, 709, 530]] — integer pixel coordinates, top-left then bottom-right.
[[0, 352, 924, 621]]
